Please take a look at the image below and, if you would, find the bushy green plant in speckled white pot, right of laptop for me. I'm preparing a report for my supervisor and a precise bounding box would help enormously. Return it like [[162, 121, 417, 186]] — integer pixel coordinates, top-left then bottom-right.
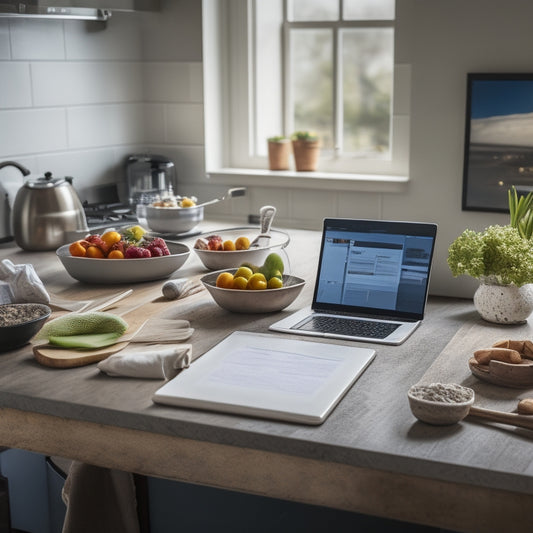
[[448, 187, 533, 324]]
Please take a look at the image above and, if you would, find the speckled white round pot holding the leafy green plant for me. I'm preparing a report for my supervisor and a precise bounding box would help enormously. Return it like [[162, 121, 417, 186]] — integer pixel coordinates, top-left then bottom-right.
[[474, 281, 533, 324]]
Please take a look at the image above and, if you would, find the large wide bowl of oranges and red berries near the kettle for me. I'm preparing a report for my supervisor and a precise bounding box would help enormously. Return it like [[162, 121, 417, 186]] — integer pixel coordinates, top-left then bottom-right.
[[56, 226, 191, 285]]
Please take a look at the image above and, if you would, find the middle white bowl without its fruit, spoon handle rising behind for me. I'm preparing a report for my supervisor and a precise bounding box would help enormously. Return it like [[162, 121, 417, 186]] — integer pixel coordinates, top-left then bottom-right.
[[193, 227, 290, 270]]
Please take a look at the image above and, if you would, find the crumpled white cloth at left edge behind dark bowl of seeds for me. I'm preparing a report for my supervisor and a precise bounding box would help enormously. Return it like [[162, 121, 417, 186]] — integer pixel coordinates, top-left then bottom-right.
[[0, 259, 50, 304]]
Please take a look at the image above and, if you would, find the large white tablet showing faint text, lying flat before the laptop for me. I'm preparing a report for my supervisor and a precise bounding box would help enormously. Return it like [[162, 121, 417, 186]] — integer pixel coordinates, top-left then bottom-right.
[[153, 331, 375, 424]]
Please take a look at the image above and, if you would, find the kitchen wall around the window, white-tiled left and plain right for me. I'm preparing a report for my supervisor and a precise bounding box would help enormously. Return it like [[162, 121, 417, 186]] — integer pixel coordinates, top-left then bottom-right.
[[0, 0, 533, 296]]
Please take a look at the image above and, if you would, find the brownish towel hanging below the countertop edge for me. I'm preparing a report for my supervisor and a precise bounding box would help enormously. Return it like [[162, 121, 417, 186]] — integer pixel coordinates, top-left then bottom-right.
[[62, 461, 140, 533]]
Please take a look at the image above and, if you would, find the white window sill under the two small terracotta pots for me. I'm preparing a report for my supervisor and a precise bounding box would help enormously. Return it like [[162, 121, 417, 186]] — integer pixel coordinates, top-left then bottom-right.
[[207, 168, 409, 193]]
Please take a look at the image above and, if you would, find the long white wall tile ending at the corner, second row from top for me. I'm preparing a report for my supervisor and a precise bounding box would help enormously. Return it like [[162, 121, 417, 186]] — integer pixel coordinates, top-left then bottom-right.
[[31, 61, 142, 106]]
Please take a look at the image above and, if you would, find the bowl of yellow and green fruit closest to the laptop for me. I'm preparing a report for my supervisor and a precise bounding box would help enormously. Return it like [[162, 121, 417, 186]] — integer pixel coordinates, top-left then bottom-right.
[[201, 252, 305, 313]]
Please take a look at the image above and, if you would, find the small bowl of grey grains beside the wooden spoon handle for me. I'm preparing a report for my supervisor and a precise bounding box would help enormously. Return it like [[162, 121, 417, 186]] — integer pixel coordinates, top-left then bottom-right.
[[407, 383, 475, 426]]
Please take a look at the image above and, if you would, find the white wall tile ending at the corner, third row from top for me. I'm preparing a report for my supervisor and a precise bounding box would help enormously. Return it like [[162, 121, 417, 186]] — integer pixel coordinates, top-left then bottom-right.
[[67, 104, 144, 148]]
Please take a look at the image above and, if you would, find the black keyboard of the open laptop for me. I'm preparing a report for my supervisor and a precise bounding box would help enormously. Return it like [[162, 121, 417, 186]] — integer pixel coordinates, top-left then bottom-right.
[[298, 315, 399, 339]]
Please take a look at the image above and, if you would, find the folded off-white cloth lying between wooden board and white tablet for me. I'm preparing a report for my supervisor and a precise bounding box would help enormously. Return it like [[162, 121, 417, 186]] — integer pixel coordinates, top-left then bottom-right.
[[97, 344, 192, 379]]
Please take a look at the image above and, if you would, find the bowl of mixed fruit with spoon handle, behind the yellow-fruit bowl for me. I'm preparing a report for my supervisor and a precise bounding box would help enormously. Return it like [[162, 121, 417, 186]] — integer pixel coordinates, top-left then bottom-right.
[[193, 227, 290, 270]]
